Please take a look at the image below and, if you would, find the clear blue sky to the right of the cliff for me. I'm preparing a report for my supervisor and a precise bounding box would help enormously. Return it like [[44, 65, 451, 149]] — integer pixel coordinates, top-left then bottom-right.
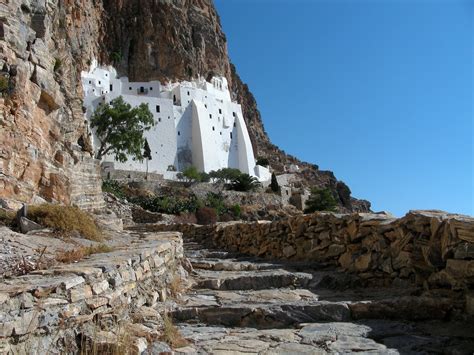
[[215, 0, 474, 215]]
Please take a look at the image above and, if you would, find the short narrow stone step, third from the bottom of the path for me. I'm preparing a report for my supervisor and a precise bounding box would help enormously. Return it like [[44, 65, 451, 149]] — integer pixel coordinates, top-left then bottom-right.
[[195, 269, 312, 290]]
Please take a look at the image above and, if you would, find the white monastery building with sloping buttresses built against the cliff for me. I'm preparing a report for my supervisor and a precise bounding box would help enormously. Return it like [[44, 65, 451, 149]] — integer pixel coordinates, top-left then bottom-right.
[[82, 63, 271, 181]]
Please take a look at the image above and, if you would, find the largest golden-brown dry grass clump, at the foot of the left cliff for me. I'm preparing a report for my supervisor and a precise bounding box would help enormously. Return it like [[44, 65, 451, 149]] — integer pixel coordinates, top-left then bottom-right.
[[28, 204, 103, 241]]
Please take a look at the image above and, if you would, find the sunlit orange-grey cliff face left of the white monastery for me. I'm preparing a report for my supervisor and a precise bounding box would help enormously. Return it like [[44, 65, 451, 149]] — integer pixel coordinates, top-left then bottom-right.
[[0, 0, 103, 208]]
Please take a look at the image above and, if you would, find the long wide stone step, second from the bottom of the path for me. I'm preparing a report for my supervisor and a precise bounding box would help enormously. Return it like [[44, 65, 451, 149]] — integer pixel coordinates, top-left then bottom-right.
[[172, 289, 453, 329]]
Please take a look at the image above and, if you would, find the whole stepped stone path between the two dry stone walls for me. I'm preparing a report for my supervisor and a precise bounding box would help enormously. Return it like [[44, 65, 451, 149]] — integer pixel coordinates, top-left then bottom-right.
[[171, 242, 474, 354]]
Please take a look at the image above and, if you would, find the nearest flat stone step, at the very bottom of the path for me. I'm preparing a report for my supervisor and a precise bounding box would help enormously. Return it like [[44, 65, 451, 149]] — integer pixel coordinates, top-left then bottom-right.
[[178, 320, 474, 355]]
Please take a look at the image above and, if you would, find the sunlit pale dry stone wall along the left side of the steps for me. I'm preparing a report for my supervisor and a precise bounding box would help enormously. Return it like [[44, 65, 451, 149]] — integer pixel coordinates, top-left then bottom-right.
[[0, 233, 183, 353]]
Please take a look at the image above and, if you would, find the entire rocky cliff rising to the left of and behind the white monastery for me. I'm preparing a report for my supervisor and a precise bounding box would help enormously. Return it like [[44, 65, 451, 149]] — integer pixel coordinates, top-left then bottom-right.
[[0, 0, 370, 211]]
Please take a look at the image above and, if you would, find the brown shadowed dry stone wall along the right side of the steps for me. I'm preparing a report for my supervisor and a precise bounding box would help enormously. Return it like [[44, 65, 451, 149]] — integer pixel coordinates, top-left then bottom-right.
[[145, 211, 474, 311]]
